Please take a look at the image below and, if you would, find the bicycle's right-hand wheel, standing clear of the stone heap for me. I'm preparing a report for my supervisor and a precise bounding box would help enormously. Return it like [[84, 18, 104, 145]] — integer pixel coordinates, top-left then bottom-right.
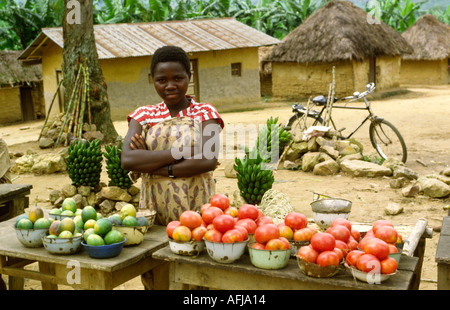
[[369, 119, 408, 163]]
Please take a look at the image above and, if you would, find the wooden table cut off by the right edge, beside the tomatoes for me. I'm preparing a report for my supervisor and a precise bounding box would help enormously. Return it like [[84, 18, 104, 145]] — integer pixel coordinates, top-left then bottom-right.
[[435, 216, 450, 290]]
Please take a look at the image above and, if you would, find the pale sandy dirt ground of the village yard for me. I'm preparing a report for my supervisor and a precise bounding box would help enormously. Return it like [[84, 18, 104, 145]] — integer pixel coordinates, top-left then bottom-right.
[[0, 85, 450, 290]]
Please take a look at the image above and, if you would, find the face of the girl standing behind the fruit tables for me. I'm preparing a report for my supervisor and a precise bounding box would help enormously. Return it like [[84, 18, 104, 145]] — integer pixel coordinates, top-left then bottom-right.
[[153, 61, 190, 106]]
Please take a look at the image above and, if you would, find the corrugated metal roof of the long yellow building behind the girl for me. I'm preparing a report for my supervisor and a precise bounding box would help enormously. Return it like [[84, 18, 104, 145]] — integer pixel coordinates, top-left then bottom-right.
[[20, 18, 281, 59]]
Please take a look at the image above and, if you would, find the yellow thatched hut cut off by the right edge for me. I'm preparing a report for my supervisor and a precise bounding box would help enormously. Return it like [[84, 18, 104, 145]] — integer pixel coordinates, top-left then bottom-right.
[[400, 14, 450, 85]]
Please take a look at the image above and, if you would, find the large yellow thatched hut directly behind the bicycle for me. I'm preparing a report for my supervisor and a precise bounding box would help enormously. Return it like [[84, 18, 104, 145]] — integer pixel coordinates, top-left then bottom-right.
[[263, 1, 412, 98]]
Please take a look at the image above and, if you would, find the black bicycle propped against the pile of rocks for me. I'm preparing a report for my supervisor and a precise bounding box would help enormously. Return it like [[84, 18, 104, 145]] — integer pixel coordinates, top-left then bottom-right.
[[284, 83, 408, 163]]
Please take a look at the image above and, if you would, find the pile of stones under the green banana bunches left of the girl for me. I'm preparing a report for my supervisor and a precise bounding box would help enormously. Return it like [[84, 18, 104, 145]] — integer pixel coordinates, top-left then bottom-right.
[[49, 182, 140, 216]]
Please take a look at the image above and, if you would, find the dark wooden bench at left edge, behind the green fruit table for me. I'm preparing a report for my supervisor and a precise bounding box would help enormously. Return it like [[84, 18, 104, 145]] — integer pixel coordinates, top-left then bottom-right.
[[0, 184, 33, 222]]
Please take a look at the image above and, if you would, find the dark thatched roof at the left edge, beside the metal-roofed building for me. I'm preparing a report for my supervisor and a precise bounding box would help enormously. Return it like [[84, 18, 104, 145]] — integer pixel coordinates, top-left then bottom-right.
[[0, 51, 42, 87]]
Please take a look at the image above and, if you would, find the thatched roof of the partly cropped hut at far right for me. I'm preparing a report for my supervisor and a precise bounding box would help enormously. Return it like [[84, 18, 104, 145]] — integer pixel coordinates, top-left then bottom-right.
[[402, 14, 450, 60]]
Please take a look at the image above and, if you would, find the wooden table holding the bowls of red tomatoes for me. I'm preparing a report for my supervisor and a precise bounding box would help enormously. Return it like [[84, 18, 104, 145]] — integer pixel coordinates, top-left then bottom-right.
[[153, 246, 420, 290]]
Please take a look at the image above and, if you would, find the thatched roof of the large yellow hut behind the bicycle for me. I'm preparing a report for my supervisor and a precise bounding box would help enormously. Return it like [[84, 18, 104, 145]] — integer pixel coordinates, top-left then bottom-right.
[[265, 1, 412, 63]]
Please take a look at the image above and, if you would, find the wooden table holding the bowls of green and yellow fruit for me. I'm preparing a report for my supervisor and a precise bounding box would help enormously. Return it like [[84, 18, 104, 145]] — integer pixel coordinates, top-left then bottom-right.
[[0, 218, 168, 289]]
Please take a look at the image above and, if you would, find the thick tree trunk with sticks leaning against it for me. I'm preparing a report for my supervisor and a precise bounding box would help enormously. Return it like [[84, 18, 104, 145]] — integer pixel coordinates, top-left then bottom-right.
[[62, 0, 118, 143]]
